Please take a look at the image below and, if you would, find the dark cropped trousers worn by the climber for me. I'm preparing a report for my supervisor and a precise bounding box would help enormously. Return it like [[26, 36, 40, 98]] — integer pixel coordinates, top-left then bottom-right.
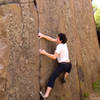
[[47, 62, 72, 88]]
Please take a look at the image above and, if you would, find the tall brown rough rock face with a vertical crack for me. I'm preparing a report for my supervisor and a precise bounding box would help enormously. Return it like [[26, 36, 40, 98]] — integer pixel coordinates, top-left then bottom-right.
[[0, 0, 100, 100]]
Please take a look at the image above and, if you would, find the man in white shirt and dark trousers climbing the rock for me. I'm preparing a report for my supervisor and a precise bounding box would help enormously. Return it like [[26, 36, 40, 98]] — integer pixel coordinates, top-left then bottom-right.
[[38, 33, 72, 99]]
